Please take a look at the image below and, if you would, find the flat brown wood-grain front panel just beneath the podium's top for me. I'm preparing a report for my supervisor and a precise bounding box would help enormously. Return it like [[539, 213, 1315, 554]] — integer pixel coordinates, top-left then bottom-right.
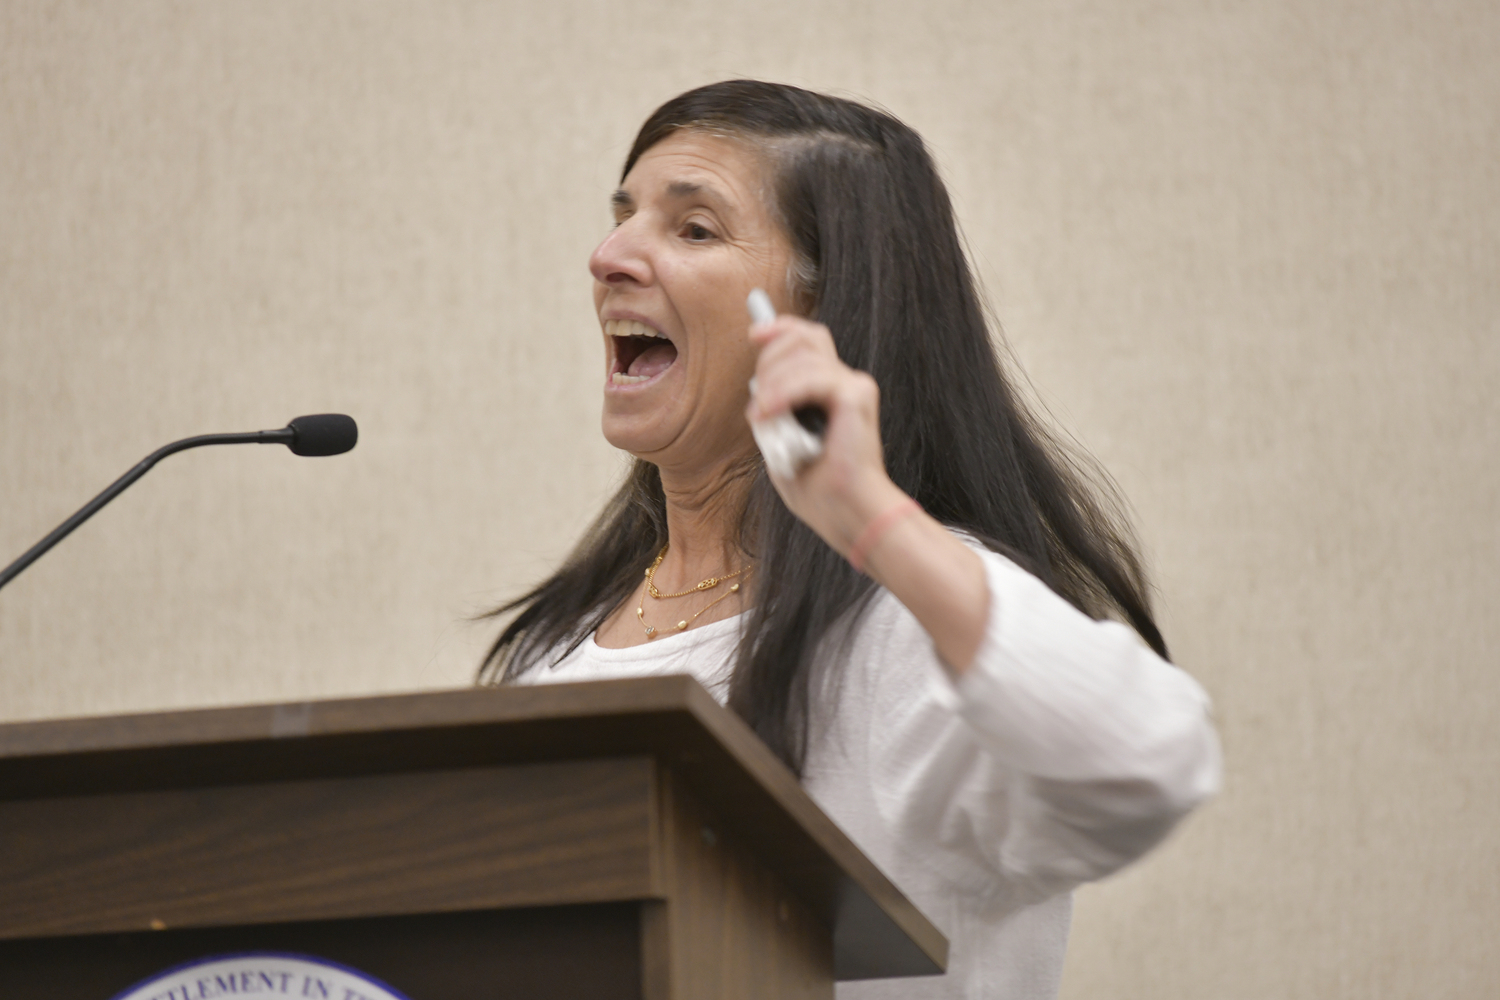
[[0, 757, 659, 939]]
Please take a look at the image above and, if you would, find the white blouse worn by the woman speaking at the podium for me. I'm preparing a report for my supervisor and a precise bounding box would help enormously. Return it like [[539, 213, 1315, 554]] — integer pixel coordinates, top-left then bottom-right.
[[522, 550, 1220, 1000]]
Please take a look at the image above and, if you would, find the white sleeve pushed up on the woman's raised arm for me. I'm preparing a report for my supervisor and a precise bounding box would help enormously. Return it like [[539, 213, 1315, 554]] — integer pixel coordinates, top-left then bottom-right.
[[851, 542, 1220, 900]]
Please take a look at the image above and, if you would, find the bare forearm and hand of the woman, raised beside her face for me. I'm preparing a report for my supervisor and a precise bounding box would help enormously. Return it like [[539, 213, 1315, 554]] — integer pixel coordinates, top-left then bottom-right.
[[747, 316, 990, 676]]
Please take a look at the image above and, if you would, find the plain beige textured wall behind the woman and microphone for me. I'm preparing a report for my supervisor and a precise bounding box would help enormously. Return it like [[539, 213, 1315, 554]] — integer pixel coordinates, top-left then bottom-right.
[[0, 0, 1500, 1000]]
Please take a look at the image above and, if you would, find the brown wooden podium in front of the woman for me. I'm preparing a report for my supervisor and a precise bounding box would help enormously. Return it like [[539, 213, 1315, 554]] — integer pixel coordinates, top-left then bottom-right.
[[0, 676, 948, 1000]]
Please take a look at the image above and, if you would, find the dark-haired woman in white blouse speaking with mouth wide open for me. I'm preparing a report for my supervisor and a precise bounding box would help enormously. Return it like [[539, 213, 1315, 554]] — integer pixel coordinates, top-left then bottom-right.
[[482, 81, 1218, 997]]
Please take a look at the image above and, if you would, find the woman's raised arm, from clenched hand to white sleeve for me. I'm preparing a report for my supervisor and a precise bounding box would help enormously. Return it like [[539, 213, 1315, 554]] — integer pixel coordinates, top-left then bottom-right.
[[749, 316, 1220, 897]]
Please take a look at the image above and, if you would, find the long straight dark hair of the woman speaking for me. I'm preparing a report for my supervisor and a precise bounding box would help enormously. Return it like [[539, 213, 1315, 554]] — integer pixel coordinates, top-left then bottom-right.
[[480, 79, 1167, 772]]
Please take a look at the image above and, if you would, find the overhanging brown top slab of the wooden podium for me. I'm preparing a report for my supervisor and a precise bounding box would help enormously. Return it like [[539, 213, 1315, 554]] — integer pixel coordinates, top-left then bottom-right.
[[0, 676, 947, 979]]
